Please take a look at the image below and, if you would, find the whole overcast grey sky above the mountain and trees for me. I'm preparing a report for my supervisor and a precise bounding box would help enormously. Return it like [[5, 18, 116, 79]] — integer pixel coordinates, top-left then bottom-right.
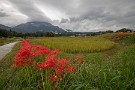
[[0, 0, 135, 32]]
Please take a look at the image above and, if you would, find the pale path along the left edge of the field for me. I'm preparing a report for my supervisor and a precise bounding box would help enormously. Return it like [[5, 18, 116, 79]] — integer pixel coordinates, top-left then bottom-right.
[[0, 42, 17, 60]]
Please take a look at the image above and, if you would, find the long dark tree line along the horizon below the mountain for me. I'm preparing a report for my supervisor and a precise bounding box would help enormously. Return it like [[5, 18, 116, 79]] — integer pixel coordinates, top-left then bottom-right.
[[0, 28, 133, 38]]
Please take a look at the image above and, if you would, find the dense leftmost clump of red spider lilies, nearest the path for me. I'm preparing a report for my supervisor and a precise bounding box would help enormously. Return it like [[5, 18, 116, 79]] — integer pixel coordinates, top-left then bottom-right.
[[16, 40, 51, 66]]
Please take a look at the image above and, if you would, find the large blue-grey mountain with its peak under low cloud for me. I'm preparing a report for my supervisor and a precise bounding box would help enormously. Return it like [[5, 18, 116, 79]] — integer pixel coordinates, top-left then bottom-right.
[[12, 21, 66, 33]]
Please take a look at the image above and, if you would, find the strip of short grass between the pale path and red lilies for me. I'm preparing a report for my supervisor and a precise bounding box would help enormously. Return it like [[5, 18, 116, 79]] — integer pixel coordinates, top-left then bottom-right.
[[0, 44, 20, 90]]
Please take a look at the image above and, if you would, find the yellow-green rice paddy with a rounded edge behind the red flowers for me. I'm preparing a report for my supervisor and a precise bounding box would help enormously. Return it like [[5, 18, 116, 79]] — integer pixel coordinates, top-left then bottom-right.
[[32, 37, 115, 53]]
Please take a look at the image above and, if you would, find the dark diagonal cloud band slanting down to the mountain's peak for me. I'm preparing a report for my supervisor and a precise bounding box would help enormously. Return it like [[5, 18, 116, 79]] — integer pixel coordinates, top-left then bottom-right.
[[9, 0, 51, 22]]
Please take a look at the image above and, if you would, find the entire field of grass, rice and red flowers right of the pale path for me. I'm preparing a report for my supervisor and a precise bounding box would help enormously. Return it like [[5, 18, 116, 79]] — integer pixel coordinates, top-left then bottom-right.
[[0, 33, 135, 90]]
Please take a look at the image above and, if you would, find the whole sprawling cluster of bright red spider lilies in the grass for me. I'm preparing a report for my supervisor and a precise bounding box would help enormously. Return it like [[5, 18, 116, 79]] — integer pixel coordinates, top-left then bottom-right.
[[15, 40, 83, 84]]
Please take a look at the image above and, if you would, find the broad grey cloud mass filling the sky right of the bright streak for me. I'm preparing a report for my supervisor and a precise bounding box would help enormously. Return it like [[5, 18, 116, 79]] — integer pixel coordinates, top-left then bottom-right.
[[41, 0, 135, 31]]
